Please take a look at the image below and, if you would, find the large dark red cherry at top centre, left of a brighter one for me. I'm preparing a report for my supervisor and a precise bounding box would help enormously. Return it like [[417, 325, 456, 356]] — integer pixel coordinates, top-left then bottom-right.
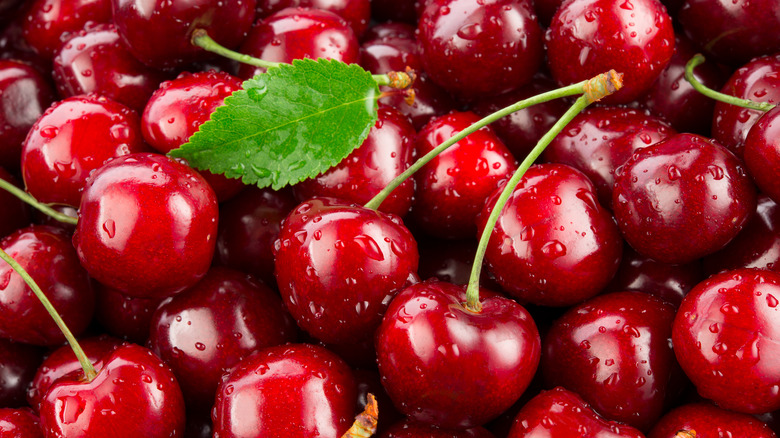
[[417, 0, 544, 98]]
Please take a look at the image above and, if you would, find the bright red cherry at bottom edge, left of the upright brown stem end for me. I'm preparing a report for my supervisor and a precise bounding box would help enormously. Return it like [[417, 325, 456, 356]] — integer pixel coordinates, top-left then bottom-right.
[[212, 344, 357, 438]]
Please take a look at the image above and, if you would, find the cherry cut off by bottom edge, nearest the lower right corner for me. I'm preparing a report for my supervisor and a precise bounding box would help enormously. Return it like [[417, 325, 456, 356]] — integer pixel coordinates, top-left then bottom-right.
[[647, 403, 776, 438]]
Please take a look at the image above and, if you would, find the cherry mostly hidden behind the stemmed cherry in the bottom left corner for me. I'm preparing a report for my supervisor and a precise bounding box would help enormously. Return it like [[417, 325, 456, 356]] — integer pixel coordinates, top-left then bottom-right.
[[27, 336, 122, 412]]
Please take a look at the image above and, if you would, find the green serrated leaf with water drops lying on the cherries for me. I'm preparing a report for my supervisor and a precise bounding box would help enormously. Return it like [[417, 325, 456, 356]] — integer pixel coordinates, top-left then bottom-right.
[[169, 59, 379, 189]]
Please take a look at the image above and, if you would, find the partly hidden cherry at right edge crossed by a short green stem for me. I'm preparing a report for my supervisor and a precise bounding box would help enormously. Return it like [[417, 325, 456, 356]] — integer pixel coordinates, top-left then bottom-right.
[[712, 54, 780, 158]]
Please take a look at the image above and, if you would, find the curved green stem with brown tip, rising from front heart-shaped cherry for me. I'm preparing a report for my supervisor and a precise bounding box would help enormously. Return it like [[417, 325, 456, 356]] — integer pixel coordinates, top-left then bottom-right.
[[466, 70, 623, 313]]
